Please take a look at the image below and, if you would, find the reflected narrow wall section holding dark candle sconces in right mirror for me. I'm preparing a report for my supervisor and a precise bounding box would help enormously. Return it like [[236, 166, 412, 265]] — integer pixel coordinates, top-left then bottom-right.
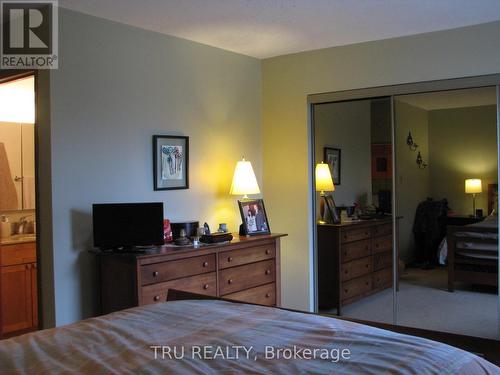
[[395, 100, 430, 263]]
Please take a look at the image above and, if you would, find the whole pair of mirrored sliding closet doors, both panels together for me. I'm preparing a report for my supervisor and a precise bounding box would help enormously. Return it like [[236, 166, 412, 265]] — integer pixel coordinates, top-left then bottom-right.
[[312, 87, 499, 338]]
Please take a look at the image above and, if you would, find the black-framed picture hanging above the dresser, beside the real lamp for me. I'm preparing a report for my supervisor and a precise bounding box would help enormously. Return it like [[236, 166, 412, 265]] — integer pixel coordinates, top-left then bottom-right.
[[153, 135, 189, 190]]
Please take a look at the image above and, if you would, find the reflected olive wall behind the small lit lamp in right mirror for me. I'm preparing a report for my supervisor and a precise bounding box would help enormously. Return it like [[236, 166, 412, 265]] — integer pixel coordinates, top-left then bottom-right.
[[429, 105, 497, 215]]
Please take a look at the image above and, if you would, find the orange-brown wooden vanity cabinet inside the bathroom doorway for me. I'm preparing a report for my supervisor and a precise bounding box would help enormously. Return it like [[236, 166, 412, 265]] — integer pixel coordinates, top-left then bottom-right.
[[0, 242, 38, 338]]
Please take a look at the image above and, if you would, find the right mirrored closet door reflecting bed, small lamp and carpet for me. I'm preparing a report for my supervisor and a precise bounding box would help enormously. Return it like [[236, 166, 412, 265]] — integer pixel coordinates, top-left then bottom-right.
[[396, 87, 498, 338]]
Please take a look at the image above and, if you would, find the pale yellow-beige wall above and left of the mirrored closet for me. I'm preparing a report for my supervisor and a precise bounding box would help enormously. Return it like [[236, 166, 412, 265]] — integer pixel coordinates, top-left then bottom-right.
[[262, 22, 500, 309]]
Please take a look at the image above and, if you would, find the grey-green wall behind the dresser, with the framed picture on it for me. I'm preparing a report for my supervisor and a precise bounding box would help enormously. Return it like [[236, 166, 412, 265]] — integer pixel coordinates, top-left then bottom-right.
[[40, 9, 262, 325]]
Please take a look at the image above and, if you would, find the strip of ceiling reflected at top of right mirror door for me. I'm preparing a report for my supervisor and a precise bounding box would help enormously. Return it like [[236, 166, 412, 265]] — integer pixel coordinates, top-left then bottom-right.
[[396, 87, 497, 111]]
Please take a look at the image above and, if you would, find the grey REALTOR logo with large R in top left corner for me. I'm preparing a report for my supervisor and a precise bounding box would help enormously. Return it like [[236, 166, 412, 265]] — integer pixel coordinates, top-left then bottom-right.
[[0, 0, 58, 69]]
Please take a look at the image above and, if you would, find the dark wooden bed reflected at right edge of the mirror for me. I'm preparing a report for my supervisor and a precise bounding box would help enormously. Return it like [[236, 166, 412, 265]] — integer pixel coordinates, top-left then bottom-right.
[[448, 215, 498, 292]]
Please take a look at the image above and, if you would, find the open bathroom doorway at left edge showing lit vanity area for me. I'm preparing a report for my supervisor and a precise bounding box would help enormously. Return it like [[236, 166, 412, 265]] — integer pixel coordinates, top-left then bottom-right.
[[0, 72, 39, 338]]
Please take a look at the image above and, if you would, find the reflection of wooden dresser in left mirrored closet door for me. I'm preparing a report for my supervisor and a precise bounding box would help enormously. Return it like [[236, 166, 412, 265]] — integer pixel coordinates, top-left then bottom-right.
[[317, 219, 393, 315]]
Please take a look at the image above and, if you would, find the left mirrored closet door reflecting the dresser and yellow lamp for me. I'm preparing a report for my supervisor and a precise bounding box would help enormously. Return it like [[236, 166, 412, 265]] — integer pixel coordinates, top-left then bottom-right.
[[313, 97, 394, 323]]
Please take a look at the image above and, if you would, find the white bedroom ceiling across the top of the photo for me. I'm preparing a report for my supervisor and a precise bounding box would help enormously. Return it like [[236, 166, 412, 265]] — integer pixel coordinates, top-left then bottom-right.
[[59, 0, 500, 58]]
